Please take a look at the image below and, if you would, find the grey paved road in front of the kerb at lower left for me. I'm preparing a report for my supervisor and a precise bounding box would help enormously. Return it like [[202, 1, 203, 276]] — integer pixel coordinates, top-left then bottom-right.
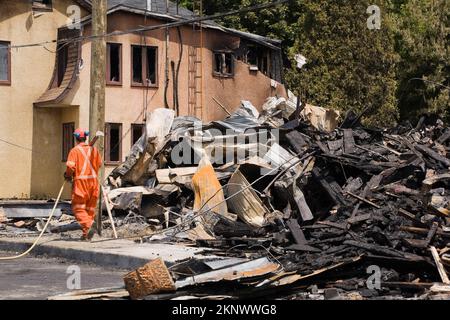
[[0, 251, 126, 300]]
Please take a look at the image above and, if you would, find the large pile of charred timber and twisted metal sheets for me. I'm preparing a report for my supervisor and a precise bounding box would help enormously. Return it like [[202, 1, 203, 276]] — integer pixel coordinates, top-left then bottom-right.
[[100, 96, 450, 299]]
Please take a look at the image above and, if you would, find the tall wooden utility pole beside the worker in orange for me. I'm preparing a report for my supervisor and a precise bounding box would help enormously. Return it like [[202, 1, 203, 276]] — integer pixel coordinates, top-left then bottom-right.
[[89, 0, 107, 235]]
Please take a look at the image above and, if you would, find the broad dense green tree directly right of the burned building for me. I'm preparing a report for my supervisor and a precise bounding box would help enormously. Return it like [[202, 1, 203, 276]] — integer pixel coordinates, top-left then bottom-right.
[[287, 0, 398, 125]]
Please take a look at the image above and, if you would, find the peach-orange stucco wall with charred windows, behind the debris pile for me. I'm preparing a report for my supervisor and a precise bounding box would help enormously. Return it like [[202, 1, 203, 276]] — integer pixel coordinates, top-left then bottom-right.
[[59, 13, 285, 178]]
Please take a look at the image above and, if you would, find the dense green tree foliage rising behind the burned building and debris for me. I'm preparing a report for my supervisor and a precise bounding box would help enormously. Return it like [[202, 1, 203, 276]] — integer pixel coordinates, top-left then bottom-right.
[[182, 0, 450, 126]]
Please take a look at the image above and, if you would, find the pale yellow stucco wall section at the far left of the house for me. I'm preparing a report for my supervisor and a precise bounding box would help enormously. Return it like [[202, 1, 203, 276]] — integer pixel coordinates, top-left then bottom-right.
[[0, 0, 85, 198]]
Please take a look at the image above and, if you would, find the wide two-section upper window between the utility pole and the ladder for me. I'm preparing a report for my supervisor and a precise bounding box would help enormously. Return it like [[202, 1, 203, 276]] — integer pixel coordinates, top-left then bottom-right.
[[131, 46, 158, 86]]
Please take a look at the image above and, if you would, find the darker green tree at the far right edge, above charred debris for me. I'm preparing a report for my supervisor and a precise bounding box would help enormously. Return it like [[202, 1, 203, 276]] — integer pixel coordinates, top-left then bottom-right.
[[395, 0, 450, 120]]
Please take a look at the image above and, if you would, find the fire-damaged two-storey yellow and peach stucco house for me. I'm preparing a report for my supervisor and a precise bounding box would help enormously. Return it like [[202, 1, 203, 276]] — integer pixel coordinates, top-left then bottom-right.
[[0, 0, 286, 198]]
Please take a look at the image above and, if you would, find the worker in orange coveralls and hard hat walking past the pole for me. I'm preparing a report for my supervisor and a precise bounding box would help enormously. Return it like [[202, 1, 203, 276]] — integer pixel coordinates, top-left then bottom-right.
[[64, 129, 102, 240]]
